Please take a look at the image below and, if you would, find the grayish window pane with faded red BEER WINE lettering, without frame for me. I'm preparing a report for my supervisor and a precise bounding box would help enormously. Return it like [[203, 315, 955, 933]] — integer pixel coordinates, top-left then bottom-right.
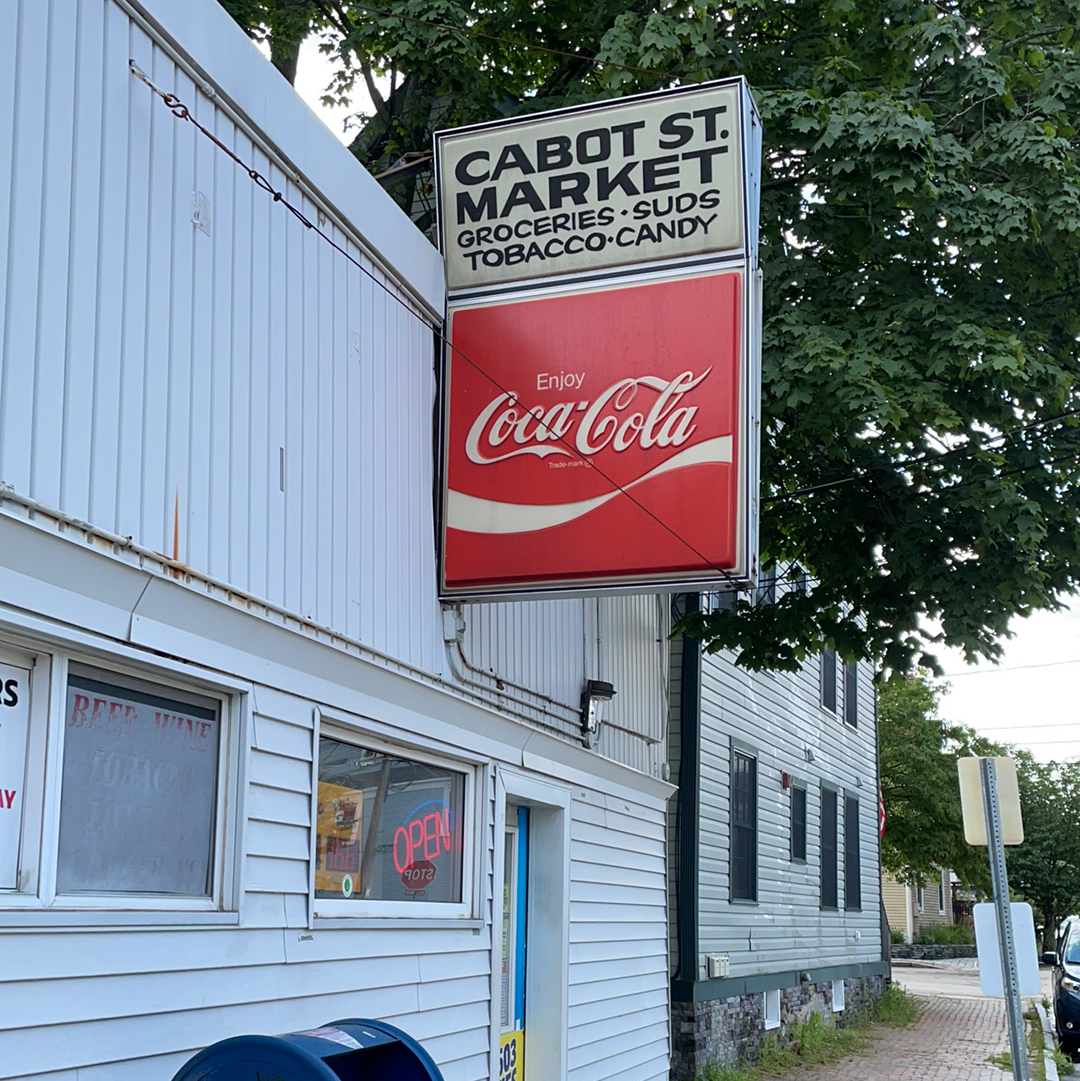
[[56, 666, 222, 897]]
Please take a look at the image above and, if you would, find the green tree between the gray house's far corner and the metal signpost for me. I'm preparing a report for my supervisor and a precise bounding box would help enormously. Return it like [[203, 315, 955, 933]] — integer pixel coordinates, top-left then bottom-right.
[[878, 673, 1004, 889]]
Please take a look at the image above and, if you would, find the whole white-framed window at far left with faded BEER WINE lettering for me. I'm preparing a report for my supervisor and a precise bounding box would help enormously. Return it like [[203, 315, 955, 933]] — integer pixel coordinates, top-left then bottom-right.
[[0, 653, 236, 925]]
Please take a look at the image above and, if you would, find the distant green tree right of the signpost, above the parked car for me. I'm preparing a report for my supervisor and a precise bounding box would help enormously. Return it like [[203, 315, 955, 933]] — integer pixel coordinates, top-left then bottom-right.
[[1005, 752, 1080, 950]]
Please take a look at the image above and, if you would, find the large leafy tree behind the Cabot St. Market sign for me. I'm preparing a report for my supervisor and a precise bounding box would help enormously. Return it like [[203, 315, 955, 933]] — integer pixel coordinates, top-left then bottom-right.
[[219, 0, 1080, 670]]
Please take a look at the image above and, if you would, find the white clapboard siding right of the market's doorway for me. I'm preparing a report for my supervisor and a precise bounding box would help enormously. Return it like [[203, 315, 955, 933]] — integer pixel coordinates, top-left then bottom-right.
[[568, 792, 669, 1081]]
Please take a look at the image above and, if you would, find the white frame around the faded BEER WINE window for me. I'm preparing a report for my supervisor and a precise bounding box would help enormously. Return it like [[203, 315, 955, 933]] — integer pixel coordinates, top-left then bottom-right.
[[0, 632, 251, 926]]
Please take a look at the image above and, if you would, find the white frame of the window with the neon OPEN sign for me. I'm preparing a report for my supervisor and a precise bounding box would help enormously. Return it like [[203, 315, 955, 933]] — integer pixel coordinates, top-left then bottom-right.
[[308, 710, 485, 927]]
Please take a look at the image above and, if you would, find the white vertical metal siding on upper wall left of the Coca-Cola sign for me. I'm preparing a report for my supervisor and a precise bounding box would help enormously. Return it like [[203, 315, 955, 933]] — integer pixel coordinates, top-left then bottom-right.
[[0, 0, 442, 669]]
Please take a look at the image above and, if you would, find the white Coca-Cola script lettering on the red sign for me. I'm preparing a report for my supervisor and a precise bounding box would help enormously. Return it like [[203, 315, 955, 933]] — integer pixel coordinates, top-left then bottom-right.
[[465, 366, 712, 466]]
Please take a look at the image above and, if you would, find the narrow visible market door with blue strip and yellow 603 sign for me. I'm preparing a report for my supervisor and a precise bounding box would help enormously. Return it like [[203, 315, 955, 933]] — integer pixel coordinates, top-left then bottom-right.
[[498, 806, 529, 1081]]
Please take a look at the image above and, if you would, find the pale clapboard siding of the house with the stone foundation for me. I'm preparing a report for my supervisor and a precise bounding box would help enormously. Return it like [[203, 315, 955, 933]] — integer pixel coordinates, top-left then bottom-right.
[[698, 635, 881, 976]]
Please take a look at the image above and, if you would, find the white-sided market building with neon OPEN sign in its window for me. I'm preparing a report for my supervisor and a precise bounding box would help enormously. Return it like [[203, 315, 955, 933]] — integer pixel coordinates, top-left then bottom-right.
[[0, 0, 672, 1081]]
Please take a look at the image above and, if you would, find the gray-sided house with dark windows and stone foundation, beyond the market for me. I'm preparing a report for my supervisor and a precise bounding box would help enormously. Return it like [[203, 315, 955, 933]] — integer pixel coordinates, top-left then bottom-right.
[[668, 596, 888, 1081]]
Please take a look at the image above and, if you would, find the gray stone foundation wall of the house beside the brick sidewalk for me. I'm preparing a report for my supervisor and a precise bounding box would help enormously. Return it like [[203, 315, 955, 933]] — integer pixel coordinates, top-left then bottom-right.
[[671, 976, 885, 1081]]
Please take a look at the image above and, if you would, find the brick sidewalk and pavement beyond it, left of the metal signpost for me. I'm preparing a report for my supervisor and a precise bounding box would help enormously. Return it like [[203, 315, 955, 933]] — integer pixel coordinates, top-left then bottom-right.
[[756, 963, 1049, 1081]]
